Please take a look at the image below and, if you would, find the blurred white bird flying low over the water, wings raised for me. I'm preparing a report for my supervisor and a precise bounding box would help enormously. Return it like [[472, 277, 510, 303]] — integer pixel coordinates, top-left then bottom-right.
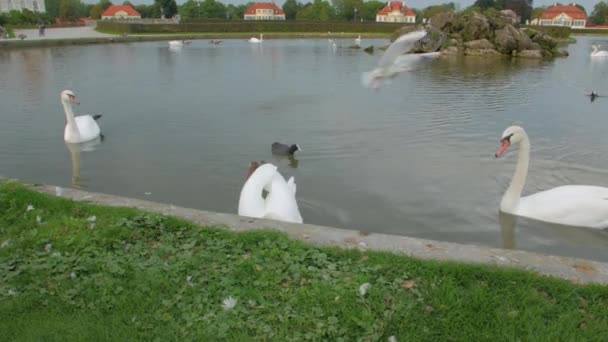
[[362, 29, 432, 89]]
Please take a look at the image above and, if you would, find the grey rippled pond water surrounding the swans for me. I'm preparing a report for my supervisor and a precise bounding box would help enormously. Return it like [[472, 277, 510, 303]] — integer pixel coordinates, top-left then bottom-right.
[[0, 36, 608, 261]]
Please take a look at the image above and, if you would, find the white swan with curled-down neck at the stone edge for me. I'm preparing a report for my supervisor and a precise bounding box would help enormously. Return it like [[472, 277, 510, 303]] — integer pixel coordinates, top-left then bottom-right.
[[238, 163, 302, 223]]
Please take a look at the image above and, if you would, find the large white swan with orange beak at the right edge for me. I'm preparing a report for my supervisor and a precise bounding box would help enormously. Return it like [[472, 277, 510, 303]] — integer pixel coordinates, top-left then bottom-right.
[[495, 126, 608, 229]]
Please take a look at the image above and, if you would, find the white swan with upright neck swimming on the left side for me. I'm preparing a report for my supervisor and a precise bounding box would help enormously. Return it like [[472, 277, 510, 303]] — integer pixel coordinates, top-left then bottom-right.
[[61, 90, 101, 143]]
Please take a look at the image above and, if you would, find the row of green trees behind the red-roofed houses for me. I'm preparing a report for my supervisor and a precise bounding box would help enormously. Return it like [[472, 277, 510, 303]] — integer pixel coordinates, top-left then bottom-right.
[[0, 0, 608, 25]]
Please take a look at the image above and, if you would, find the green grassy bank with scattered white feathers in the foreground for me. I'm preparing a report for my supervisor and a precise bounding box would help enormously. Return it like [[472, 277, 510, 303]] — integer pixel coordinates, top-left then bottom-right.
[[0, 183, 608, 341]]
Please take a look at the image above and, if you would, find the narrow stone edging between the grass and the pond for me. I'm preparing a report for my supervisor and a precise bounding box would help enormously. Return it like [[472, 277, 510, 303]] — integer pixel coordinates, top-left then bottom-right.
[[0, 178, 608, 284]]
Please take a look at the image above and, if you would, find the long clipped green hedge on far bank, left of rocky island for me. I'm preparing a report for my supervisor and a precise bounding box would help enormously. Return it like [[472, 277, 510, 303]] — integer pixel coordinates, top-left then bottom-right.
[[97, 21, 404, 33]]
